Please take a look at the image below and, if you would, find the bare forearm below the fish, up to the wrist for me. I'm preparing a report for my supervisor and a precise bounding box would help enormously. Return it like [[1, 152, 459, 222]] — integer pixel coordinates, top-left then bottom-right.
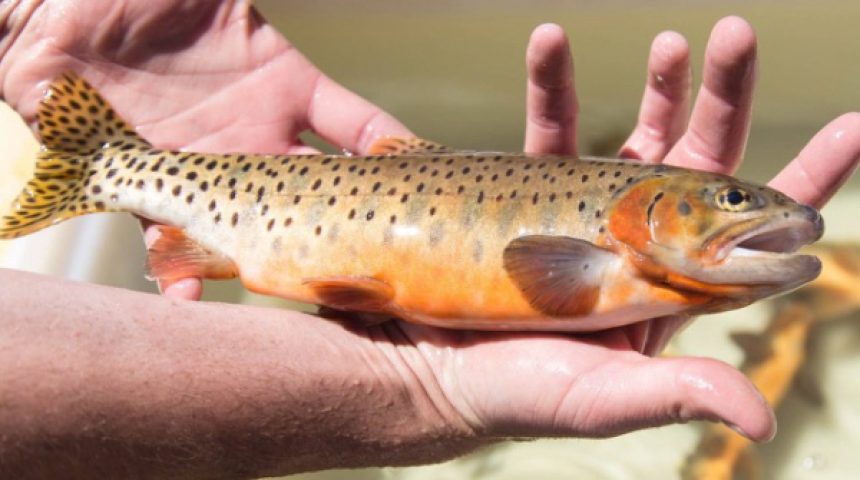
[[0, 270, 478, 478]]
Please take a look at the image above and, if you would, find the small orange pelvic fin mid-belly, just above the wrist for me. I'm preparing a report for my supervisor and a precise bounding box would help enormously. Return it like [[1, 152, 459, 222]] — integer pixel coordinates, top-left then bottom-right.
[[302, 277, 394, 312]]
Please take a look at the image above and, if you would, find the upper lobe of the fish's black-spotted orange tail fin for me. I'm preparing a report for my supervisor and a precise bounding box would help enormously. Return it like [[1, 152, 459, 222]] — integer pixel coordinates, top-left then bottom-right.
[[36, 73, 151, 155]]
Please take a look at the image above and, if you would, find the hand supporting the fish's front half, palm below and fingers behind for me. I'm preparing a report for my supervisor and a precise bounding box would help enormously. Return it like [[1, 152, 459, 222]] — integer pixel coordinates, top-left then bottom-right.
[[370, 17, 860, 448]]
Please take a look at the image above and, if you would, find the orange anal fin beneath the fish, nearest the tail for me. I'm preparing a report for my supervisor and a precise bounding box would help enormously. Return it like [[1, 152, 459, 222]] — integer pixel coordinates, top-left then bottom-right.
[[147, 225, 239, 280]]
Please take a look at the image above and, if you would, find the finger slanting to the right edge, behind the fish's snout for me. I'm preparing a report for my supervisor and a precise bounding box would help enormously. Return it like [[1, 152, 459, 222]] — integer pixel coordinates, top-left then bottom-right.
[[770, 112, 860, 208]]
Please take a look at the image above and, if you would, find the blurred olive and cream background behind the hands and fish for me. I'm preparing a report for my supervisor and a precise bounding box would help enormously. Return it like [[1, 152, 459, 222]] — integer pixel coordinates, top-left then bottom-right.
[[0, 0, 860, 480]]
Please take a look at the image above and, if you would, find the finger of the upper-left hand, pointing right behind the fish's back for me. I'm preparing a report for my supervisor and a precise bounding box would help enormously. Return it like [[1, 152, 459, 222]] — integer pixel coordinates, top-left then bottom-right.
[[307, 74, 414, 153]]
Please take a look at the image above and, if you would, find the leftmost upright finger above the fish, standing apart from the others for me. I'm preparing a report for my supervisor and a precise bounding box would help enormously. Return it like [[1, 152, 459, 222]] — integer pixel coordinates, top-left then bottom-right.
[[524, 23, 578, 155]]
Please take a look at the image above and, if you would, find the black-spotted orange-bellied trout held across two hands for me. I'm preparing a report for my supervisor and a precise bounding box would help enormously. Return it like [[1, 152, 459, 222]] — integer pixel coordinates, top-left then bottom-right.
[[0, 73, 824, 332]]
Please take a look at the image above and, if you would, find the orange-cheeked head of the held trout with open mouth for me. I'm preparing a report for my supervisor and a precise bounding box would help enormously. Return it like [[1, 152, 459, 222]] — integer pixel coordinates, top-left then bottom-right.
[[606, 169, 824, 301]]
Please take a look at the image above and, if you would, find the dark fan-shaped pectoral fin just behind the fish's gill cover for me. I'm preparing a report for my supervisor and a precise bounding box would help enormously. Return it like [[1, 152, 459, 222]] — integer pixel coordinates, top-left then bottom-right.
[[503, 235, 616, 317]]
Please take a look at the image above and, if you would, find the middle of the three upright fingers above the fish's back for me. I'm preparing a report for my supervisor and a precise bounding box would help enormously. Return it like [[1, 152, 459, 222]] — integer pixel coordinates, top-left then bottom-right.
[[620, 32, 691, 163]]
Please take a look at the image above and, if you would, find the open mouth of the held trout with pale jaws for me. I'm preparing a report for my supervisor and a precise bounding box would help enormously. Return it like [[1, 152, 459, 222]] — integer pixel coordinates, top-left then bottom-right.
[[691, 207, 824, 291]]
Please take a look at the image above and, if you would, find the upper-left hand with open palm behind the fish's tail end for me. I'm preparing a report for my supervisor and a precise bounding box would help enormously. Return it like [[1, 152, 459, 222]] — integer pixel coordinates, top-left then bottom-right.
[[0, 0, 411, 300]]
